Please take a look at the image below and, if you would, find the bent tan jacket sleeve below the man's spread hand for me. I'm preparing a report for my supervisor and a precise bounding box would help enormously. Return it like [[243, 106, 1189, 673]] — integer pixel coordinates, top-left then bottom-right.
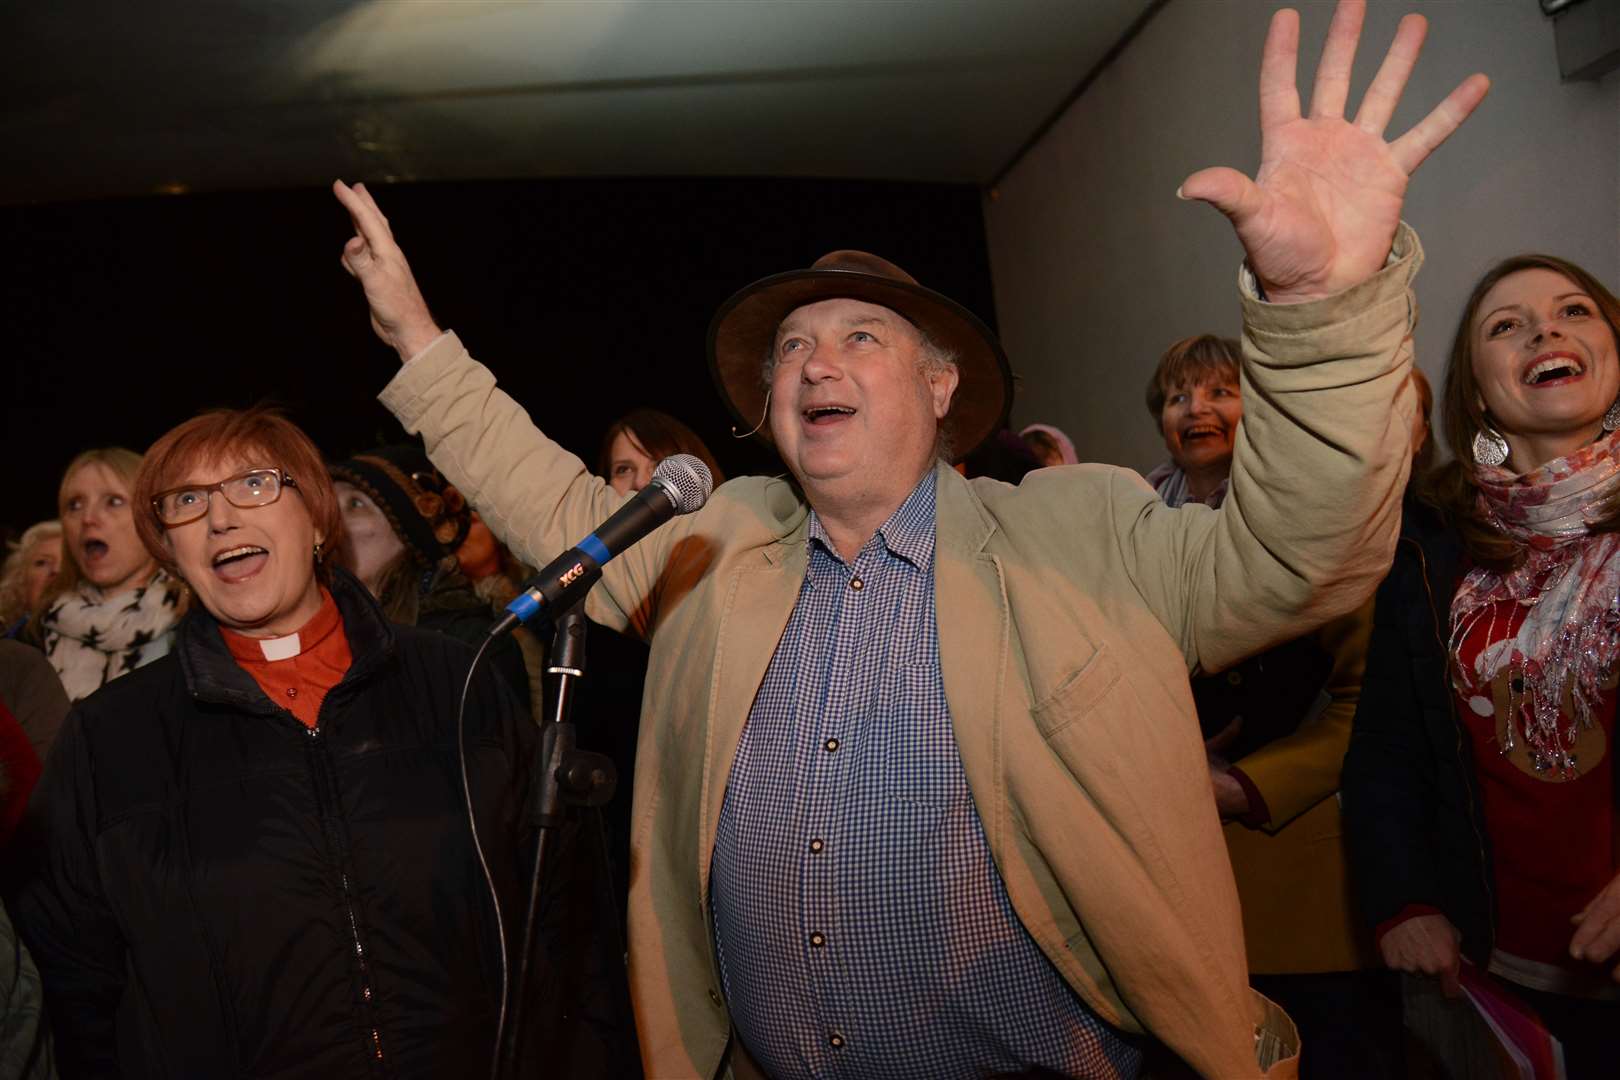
[[1111, 223, 1422, 670]]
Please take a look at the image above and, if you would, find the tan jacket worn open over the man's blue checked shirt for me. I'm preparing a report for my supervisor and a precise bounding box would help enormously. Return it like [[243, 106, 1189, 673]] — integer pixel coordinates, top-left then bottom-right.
[[382, 228, 1421, 1080]]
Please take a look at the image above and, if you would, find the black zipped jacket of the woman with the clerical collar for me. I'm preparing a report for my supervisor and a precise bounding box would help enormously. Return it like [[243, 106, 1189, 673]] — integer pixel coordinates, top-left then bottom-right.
[[13, 576, 535, 1077]]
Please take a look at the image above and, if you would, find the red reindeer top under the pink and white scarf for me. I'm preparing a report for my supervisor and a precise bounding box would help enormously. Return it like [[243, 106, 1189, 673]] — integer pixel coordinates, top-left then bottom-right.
[[1456, 601, 1617, 973]]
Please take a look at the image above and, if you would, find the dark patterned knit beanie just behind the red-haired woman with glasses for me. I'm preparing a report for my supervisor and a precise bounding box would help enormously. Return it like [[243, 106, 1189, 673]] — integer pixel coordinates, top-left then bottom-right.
[[329, 444, 473, 568]]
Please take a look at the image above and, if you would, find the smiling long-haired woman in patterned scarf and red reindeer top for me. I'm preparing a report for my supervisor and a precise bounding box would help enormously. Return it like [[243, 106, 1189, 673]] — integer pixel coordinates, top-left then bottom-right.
[[1345, 254, 1620, 1080]]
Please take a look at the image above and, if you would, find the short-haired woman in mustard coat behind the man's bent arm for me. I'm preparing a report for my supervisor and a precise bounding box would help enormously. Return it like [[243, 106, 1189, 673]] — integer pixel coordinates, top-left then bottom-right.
[[1147, 334, 1416, 1080]]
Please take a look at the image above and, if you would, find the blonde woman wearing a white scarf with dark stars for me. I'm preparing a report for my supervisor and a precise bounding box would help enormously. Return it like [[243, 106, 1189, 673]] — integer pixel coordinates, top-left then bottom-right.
[[41, 447, 185, 701]]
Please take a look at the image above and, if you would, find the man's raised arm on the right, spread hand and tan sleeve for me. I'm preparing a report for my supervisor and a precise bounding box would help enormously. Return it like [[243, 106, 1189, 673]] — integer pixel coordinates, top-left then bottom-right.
[[1116, 0, 1489, 670]]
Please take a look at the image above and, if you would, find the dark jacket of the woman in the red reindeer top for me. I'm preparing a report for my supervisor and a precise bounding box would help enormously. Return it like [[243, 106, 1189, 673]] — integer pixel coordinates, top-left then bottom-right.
[[1341, 499, 1495, 963]]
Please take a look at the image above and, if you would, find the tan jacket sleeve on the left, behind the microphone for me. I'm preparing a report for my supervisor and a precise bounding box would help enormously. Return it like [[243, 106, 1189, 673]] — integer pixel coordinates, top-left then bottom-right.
[[379, 334, 679, 638]]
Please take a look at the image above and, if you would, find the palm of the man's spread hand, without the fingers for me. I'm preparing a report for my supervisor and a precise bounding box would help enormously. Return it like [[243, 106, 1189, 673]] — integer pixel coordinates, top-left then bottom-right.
[[1234, 118, 1408, 301]]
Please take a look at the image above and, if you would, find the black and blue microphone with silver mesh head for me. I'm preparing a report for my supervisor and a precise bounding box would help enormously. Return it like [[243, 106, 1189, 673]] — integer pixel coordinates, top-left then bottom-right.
[[489, 453, 714, 638]]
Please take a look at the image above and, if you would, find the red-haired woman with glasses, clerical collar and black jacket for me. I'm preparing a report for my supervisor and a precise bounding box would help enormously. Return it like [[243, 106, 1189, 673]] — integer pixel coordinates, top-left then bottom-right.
[[13, 410, 535, 1077]]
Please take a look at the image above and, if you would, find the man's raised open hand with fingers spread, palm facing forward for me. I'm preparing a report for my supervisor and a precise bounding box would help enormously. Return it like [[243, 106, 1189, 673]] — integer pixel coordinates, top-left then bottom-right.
[[1181, 0, 1490, 303]]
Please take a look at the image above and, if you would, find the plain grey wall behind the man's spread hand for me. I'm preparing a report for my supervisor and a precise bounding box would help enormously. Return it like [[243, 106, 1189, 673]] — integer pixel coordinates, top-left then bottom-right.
[[985, 0, 1620, 470]]
